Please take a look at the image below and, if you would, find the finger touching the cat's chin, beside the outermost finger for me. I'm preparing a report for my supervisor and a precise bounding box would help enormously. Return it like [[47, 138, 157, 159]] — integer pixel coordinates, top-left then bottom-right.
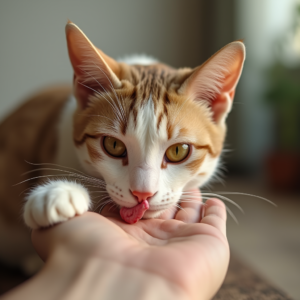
[[175, 189, 203, 223]]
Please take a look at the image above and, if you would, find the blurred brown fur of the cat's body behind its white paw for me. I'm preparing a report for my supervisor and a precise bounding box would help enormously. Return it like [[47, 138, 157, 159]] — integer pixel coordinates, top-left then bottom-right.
[[0, 86, 71, 228]]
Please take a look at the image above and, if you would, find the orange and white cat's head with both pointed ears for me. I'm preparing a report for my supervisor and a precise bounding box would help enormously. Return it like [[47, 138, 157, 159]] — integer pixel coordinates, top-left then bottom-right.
[[66, 23, 245, 217]]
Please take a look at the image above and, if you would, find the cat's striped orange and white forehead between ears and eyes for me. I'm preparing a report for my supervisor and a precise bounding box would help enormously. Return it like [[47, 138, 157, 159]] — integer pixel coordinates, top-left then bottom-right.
[[74, 64, 220, 157]]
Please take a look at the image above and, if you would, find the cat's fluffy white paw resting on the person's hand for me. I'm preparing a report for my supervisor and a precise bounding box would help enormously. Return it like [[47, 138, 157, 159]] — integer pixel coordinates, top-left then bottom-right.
[[24, 180, 90, 229]]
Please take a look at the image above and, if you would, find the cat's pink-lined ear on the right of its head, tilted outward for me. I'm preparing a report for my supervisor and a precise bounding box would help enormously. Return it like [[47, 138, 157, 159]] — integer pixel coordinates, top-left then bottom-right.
[[178, 41, 246, 124]]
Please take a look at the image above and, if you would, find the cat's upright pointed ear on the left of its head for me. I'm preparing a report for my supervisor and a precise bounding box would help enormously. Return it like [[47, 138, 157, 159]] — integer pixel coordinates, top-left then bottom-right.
[[66, 22, 122, 109]]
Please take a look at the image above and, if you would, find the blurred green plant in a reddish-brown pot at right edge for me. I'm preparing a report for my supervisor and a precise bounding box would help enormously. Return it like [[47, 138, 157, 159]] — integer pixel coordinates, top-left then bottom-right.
[[265, 5, 300, 190]]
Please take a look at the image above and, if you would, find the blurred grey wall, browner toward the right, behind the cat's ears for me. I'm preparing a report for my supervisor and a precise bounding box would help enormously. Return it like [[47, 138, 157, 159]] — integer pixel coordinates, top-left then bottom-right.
[[0, 0, 204, 119]]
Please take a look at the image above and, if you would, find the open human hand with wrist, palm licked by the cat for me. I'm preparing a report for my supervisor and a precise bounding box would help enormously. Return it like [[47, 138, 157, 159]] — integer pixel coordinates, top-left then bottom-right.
[[3, 192, 229, 300]]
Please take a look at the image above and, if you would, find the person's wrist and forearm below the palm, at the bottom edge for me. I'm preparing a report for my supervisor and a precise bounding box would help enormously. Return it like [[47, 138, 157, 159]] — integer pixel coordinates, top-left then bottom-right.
[[2, 248, 189, 300]]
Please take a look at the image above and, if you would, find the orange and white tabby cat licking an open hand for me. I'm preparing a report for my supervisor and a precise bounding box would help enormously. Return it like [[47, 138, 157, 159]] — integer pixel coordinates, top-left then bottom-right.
[[0, 22, 245, 268]]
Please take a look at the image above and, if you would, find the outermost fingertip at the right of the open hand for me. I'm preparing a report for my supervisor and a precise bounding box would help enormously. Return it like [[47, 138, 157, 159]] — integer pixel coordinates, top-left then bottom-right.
[[200, 198, 227, 237]]
